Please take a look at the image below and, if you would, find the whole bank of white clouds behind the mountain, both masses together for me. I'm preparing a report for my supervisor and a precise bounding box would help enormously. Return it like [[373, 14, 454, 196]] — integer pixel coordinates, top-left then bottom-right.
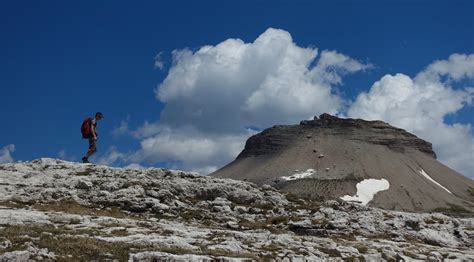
[[121, 28, 474, 177]]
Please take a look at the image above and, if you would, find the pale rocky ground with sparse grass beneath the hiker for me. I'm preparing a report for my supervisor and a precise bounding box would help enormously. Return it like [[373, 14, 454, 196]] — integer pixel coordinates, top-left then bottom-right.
[[0, 159, 474, 261]]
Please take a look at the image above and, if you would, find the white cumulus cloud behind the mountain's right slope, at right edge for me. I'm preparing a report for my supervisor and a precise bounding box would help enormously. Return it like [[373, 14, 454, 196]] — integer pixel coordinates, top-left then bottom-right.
[[348, 54, 474, 177]]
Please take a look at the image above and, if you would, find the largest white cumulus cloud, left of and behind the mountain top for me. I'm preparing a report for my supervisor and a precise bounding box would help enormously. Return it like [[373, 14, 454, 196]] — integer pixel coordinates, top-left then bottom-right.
[[132, 28, 371, 173]]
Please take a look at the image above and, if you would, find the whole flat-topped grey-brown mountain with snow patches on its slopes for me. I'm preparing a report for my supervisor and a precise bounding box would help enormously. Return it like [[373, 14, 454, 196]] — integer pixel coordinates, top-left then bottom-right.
[[211, 114, 474, 211]]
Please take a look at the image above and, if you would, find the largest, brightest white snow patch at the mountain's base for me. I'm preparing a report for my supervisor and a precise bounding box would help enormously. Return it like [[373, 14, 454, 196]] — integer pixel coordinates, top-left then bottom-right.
[[341, 178, 390, 206]]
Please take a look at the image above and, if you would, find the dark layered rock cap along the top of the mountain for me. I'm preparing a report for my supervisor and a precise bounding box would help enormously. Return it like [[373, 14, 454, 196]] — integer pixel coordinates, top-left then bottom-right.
[[241, 114, 436, 159]]
